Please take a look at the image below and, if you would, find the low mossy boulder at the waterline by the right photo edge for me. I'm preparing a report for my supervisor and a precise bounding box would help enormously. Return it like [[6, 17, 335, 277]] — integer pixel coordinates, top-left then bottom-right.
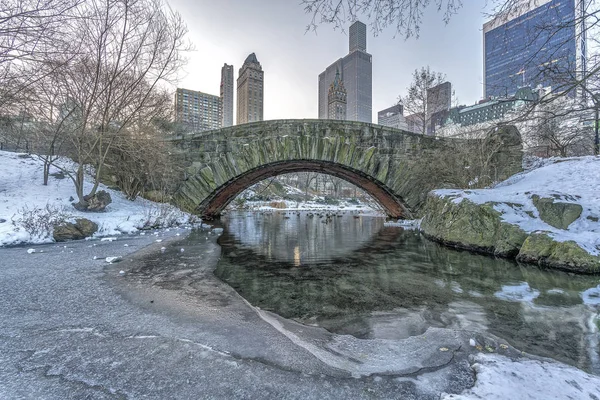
[[517, 232, 600, 273]]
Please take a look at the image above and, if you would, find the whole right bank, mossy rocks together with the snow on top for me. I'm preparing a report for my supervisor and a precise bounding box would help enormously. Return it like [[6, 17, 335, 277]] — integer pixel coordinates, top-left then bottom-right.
[[421, 157, 600, 273]]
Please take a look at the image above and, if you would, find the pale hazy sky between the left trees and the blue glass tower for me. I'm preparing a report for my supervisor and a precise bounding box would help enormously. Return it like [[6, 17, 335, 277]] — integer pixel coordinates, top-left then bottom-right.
[[170, 0, 486, 122]]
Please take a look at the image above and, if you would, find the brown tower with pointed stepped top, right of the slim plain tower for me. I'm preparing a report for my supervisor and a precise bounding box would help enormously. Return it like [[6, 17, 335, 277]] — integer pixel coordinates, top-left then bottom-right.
[[237, 53, 264, 124]]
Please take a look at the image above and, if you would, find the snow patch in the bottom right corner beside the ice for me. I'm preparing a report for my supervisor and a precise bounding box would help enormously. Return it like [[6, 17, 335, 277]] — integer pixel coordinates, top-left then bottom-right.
[[442, 354, 600, 400]]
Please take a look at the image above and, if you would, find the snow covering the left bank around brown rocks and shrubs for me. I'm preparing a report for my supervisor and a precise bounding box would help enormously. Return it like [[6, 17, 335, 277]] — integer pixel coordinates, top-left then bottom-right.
[[0, 151, 190, 246]]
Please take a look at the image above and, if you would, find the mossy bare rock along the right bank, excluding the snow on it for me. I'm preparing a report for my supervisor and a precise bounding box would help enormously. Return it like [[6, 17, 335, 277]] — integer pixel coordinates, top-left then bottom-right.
[[421, 193, 600, 273]]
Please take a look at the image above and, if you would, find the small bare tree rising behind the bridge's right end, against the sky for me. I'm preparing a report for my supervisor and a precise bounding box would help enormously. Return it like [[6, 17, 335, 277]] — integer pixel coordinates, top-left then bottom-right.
[[398, 66, 446, 135]]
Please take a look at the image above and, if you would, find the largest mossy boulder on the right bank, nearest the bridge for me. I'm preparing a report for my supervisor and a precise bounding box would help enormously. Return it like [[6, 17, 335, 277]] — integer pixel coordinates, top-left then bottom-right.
[[421, 193, 527, 257]]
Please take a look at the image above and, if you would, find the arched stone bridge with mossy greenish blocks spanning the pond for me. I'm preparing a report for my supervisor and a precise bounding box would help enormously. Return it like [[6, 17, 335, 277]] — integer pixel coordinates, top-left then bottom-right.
[[173, 120, 522, 219]]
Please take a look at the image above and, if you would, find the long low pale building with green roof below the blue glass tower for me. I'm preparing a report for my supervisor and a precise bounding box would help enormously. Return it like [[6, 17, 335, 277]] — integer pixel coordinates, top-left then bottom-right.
[[444, 87, 539, 126]]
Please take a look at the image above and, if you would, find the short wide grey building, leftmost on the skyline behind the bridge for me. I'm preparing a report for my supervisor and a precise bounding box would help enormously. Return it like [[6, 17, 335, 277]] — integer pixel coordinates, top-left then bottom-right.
[[175, 88, 222, 132]]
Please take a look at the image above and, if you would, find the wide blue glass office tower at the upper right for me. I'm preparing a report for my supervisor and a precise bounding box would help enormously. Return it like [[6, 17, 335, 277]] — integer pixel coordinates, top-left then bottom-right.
[[483, 0, 586, 98]]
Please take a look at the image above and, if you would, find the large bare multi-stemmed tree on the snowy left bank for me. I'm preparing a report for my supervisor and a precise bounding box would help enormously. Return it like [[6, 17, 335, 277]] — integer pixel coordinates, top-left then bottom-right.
[[40, 0, 187, 209]]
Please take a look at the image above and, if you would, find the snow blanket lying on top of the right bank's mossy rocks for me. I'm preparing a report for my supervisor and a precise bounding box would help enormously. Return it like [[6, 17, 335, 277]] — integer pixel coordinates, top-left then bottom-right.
[[435, 156, 600, 255]]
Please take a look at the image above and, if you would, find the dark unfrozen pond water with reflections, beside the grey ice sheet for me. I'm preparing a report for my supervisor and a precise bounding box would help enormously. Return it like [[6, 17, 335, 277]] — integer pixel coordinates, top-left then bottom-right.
[[215, 217, 600, 372]]
